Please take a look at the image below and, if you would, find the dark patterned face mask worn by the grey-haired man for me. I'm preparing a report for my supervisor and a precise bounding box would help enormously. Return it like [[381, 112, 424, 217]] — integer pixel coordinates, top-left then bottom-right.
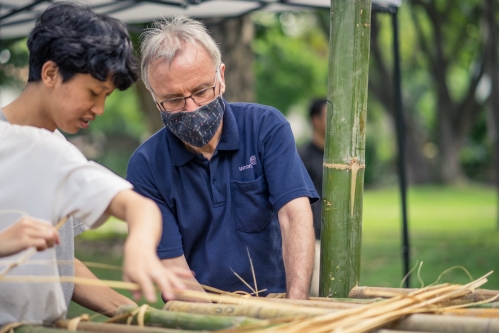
[[160, 96, 224, 148]]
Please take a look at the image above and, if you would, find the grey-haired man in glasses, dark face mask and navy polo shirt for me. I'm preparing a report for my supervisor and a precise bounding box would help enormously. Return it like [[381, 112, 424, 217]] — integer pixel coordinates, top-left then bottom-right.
[[127, 17, 318, 299]]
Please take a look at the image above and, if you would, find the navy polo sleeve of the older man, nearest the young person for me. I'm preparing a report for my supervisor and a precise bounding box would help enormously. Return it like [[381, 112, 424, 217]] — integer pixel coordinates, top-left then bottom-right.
[[127, 152, 184, 259]]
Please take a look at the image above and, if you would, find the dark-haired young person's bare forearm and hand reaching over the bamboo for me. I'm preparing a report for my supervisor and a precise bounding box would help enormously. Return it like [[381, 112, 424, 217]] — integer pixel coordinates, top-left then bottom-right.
[[105, 190, 192, 302]]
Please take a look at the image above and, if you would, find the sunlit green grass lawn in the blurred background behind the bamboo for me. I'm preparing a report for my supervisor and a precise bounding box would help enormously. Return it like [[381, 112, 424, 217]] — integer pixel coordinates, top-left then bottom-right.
[[68, 186, 499, 320]]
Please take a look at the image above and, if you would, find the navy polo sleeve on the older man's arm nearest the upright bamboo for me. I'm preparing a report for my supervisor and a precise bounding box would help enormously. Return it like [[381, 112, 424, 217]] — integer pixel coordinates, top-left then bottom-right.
[[262, 115, 319, 212]]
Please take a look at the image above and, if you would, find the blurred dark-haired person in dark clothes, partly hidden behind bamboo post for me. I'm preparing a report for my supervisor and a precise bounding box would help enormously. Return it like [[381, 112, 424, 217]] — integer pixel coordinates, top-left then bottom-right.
[[299, 98, 326, 296]]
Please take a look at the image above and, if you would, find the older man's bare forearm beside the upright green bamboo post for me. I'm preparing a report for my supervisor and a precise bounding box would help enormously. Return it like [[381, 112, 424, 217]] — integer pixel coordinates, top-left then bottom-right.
[[278, 197, 315, 299]]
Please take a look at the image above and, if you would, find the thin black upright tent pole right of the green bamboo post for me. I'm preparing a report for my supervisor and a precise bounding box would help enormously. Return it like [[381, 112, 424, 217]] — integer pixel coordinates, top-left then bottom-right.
[[391, 7, 410, 288]]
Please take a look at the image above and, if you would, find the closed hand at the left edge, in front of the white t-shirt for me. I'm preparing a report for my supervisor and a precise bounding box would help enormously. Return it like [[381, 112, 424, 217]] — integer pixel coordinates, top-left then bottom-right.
[[0, 216, 59, 257]]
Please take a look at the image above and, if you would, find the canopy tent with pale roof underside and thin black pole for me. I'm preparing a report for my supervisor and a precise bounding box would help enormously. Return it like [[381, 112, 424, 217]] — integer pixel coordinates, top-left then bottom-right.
[[0, 0, 410, 287]]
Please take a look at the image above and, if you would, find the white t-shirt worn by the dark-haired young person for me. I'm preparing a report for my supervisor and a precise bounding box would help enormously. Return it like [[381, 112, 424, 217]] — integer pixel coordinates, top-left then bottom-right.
[[0, 121, 132, 325]]
